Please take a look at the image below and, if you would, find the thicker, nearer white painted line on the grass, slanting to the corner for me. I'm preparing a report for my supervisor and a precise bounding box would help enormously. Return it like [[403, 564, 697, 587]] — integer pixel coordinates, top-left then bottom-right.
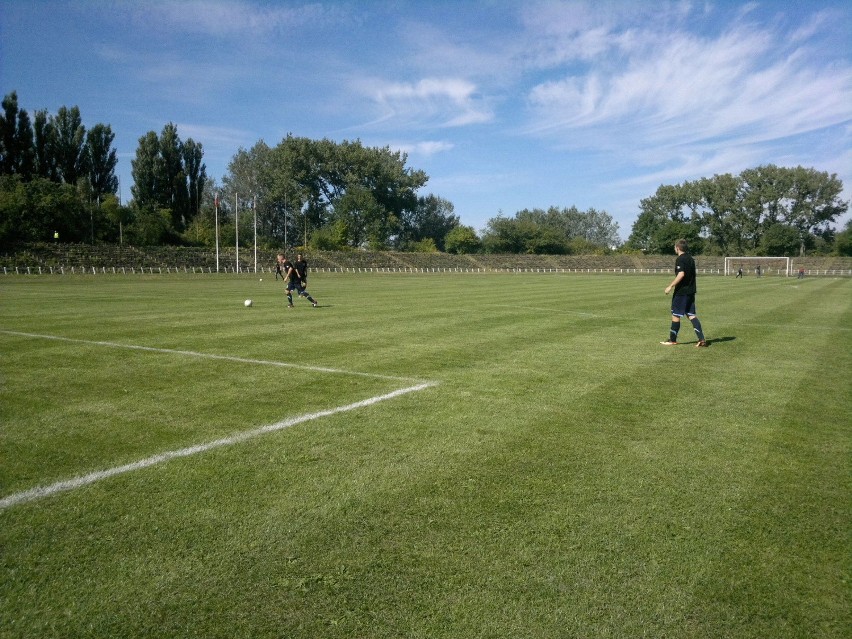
[[0, 382, 437, 510]]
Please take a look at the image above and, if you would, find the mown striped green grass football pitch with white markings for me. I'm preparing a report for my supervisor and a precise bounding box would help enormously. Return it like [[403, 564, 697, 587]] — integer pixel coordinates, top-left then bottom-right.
[[0, 274, 852, 639]]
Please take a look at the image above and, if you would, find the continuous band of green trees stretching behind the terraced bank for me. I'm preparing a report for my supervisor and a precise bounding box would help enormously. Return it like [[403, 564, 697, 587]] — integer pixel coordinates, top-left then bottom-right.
[[0, 92, 852, 255]]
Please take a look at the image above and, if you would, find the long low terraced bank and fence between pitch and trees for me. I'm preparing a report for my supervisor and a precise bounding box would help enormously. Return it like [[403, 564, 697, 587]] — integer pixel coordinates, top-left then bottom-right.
[[0, 243, 852, 276]]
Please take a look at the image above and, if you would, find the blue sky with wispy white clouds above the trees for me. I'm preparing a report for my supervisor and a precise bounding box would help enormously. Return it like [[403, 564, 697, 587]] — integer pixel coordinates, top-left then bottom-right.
[[0, 0, 852, 239]]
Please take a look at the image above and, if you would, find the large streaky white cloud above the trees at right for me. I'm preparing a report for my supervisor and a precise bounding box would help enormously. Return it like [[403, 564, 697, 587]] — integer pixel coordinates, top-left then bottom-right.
[[525, 6, 852, 184]]
